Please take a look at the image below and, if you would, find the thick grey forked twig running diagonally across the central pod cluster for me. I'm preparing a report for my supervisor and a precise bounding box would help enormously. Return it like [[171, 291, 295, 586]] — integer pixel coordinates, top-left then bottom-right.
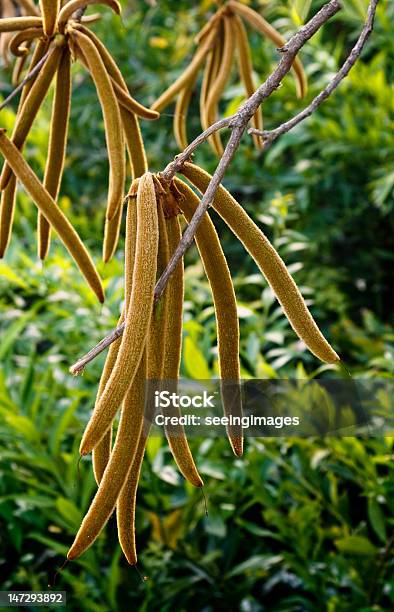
[[70, 0, 378, 375]]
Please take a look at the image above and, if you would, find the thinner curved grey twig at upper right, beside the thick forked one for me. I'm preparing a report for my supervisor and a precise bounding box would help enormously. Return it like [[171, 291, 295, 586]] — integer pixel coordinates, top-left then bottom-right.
[[248, 0, 379, 146]]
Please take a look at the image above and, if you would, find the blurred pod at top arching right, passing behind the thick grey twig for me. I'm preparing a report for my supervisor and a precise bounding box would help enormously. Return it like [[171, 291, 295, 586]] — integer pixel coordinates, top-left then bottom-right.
[[228, 0, 308, 98]]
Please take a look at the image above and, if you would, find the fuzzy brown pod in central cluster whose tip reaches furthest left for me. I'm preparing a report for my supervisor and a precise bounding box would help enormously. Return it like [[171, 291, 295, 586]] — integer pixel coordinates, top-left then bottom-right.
[[67, 351, 146, 559]]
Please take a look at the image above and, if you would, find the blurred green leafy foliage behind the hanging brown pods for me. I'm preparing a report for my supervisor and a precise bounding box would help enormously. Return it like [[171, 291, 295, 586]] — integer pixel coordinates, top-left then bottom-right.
[[0, 0, 394, 612]]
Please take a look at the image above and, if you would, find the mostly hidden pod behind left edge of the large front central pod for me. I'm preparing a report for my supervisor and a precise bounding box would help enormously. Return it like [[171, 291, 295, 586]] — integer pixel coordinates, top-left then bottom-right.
[[92, 196, 137, 484]]
